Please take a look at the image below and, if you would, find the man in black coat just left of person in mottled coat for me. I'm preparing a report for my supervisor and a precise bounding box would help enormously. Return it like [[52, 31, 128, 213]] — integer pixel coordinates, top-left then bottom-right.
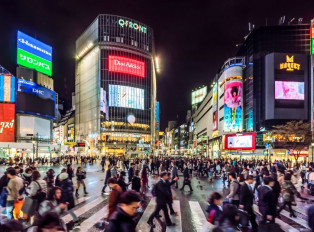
[[258, 176, 277, 222]]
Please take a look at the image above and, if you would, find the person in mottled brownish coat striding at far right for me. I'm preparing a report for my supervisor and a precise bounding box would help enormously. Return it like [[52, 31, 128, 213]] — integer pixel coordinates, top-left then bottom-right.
[[277, 173, 300, 218]]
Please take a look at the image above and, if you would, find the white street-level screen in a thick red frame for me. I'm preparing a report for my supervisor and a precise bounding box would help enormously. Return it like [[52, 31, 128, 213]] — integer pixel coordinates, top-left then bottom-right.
[[225, 133, 255, 150]]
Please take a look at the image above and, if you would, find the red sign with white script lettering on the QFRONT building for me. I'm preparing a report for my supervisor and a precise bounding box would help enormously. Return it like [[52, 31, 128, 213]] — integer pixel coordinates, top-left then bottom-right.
[[109, 56, 145, 77]]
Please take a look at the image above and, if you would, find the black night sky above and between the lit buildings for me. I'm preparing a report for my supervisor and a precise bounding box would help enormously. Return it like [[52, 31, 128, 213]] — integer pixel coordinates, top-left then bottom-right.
[[0, 0, 314, 128]]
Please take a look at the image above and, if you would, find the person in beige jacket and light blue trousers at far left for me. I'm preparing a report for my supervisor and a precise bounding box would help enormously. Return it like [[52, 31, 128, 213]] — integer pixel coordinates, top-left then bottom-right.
[[6, 168, 24, 220]]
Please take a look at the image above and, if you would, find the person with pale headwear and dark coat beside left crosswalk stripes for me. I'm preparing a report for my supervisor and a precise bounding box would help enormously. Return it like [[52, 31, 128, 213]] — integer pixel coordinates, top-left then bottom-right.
[[59, 172, 79, 228]]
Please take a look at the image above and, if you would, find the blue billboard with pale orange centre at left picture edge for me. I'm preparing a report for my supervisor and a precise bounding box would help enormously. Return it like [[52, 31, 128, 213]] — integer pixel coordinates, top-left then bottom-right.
[[0, 74, 15, 102]]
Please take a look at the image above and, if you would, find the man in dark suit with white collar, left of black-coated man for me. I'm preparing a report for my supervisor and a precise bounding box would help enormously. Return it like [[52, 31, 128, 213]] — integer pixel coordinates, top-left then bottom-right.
[[239, 175, 258, 232]]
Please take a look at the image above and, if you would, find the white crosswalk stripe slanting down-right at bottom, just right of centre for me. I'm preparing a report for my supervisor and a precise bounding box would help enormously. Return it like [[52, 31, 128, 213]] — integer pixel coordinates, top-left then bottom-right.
[[189, 201, 215, 232]]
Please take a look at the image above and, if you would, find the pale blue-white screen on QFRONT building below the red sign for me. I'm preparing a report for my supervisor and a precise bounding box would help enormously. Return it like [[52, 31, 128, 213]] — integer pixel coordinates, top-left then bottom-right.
[[109, 85, 144, 110]]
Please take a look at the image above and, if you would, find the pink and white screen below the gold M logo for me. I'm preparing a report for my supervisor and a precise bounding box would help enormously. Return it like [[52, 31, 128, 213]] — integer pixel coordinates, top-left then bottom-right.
[[275, 81, 304, 100]]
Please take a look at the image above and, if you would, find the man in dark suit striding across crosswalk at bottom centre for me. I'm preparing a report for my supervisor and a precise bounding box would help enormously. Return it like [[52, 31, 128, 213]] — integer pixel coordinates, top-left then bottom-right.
[[147, 172, 175, 228]]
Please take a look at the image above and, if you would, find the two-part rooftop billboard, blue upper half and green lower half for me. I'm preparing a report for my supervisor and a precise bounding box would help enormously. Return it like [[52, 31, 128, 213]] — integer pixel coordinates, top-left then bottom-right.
[[17, 31, 52, 76]]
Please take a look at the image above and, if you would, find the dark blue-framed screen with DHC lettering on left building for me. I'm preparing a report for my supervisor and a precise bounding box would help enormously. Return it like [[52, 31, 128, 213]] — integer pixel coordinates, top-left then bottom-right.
[[16, 79, 56, 119]]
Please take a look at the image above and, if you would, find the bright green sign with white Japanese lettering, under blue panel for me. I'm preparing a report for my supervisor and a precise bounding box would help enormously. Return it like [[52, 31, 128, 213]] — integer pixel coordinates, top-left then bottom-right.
[[17, 48, 52, 76]]
